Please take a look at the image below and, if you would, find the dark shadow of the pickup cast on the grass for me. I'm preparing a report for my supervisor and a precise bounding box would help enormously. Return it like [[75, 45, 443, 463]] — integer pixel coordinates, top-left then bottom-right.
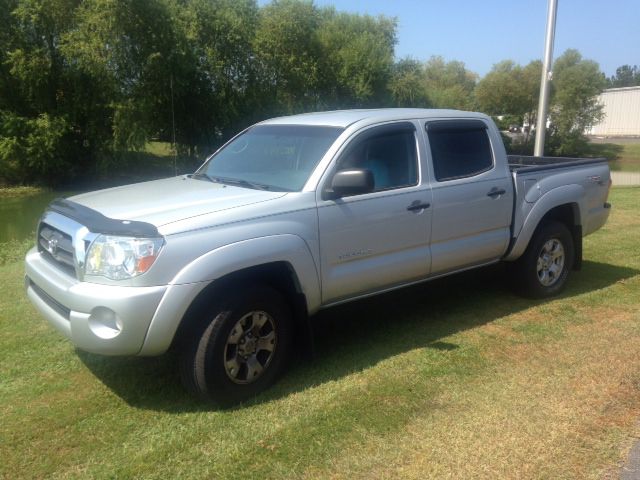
[[78, 261, 640, 413]]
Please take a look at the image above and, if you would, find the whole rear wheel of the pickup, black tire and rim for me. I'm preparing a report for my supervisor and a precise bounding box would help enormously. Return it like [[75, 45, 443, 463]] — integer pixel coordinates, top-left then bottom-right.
[[511, 221, 575, 298]]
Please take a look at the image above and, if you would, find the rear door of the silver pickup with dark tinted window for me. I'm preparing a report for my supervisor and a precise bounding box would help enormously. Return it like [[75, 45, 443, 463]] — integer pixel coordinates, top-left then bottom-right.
[[425, 119, 513, 274]]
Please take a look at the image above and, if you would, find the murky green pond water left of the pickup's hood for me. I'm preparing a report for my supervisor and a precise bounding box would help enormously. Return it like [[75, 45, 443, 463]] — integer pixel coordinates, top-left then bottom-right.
[[0, 191, 74, 243]]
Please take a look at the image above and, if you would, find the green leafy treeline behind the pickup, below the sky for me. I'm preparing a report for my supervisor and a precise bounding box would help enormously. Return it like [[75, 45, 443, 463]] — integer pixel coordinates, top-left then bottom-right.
[[0, 0, 620, 184]]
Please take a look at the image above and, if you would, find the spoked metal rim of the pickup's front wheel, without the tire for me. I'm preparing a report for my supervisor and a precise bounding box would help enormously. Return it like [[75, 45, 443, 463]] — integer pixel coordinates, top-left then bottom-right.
[[224, 311, 277, 384]]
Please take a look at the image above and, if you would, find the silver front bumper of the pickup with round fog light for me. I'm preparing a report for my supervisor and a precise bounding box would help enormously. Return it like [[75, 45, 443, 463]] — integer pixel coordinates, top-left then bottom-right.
[[25, 248, 168, 355]]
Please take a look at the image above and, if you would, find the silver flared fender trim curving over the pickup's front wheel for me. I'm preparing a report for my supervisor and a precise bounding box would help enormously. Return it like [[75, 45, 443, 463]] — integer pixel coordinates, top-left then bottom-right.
[[140, 234, 320, 355]]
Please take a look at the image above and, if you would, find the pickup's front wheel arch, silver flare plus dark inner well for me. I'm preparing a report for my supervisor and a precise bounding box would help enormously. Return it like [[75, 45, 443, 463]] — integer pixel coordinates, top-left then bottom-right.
[[139, 234, 320, 356]]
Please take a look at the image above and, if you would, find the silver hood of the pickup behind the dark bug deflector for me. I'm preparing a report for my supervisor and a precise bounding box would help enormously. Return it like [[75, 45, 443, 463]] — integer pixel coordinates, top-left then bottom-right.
[[69, 176, 286, 227]]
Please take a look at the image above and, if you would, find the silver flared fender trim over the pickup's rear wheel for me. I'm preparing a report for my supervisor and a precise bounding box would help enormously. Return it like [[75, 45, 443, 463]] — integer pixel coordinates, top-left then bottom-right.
[[505, 184, 585, 261]]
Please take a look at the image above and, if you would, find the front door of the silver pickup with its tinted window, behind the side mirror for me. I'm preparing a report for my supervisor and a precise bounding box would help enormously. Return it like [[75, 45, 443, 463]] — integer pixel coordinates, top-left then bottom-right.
[[318, 122, 431, 304]]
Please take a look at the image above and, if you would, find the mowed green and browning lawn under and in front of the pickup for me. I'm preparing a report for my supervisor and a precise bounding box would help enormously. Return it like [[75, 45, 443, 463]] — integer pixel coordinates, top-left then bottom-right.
[[0, 188, 640, 479]]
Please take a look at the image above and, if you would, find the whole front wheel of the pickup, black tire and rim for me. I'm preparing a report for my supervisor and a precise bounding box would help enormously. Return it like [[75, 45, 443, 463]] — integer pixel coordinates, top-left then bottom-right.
[[181, 285, 292, 406]]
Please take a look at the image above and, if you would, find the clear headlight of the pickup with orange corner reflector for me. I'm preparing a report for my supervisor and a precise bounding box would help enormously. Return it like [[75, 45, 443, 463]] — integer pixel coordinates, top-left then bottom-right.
[[84, 235, 164, 280]]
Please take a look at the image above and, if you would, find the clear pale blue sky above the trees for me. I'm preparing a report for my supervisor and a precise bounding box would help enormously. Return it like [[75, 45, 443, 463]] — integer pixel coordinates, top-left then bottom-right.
[[259, 0, 640, 76]]
